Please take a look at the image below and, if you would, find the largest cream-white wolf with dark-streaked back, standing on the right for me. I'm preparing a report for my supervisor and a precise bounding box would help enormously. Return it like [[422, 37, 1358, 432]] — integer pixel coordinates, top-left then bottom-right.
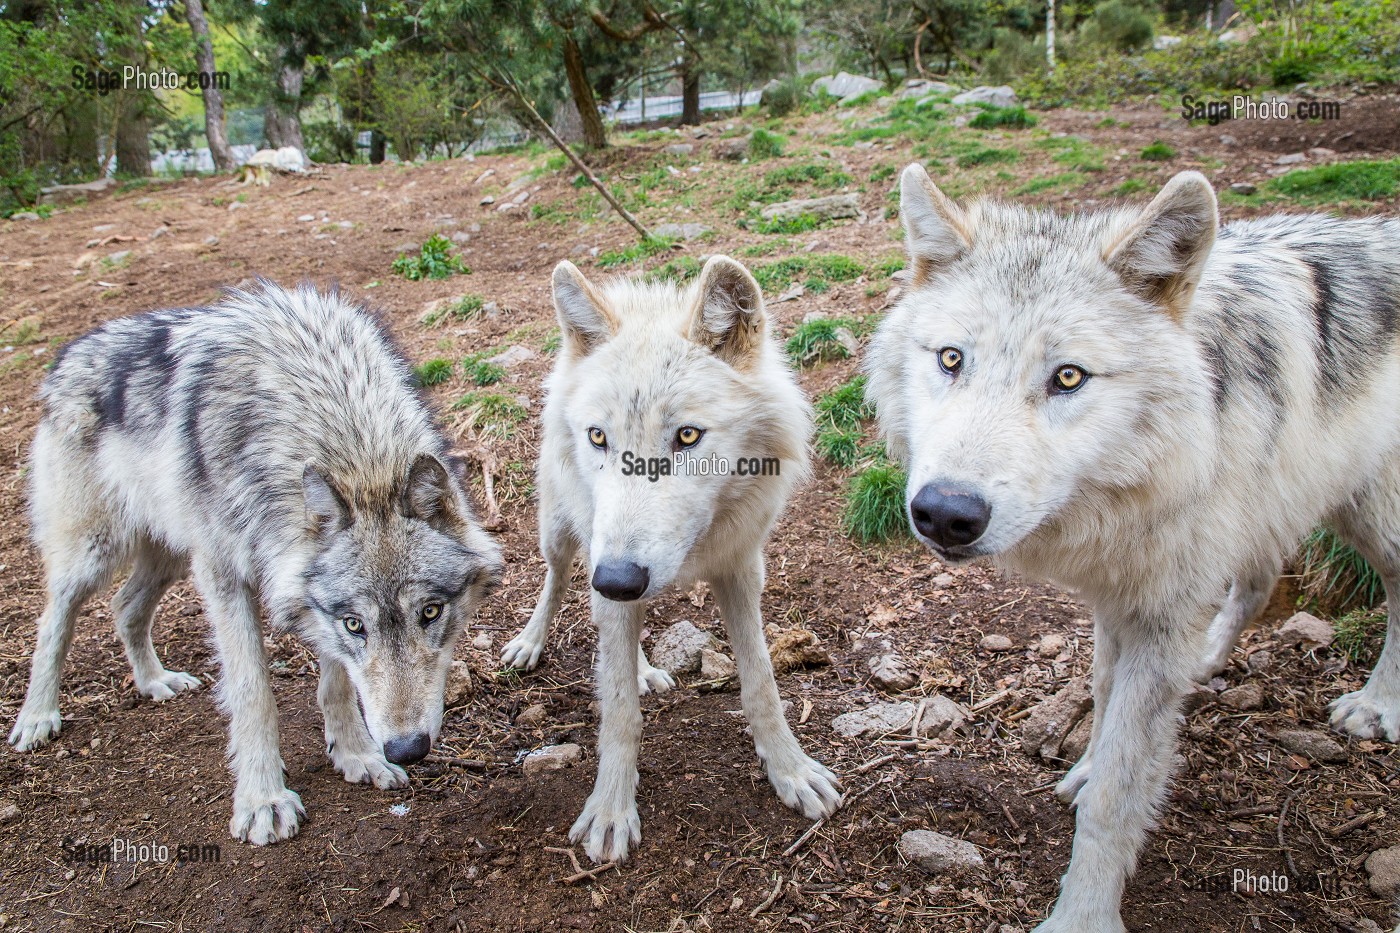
[[867, 165, 1400, 933]]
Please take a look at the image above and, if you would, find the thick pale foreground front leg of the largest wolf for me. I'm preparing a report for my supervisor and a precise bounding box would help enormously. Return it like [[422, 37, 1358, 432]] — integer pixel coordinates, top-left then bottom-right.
[[1035, 619, 1198, 933]]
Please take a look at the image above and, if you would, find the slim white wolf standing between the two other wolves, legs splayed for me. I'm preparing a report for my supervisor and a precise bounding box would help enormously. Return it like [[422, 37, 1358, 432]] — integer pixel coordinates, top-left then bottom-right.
[[505, 256, 840, 862]]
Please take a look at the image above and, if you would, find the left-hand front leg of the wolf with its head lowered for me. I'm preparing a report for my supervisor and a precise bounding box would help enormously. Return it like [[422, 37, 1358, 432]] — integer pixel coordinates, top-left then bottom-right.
[[195, 560, 307, 846]]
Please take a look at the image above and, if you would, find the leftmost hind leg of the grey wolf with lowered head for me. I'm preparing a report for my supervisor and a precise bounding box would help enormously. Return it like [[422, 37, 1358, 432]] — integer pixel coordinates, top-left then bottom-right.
[[10, 528, 120, 751]]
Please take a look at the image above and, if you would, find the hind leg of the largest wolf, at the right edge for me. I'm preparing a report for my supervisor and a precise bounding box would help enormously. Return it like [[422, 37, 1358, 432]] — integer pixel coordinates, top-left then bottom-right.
[[1331, 476, 1400, 742]]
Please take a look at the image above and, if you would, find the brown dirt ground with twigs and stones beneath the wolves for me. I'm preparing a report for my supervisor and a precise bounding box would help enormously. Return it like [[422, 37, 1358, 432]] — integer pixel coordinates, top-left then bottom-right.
[[0, 94, 1400, 933]]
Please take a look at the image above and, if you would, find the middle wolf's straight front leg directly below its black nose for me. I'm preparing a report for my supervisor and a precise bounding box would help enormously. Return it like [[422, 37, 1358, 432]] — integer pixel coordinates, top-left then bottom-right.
[[568, 591, 647, 862]]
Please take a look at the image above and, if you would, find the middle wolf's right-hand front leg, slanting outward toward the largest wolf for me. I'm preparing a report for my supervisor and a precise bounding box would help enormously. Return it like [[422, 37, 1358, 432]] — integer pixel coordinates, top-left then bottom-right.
[[710, 552, 841, 820]]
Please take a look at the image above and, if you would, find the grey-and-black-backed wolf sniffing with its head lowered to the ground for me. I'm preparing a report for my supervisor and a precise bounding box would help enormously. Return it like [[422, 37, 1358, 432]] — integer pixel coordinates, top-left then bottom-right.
[[10, 283, 501, 845]]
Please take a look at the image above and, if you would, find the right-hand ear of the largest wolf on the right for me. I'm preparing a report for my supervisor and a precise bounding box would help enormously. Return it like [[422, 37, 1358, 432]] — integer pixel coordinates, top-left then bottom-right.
[[1103, 172, 1219, 315]]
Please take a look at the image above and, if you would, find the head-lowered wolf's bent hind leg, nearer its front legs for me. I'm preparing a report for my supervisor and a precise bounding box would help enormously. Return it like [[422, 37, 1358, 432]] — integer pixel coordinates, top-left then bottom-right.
[[112, 541, 200, 700]]
